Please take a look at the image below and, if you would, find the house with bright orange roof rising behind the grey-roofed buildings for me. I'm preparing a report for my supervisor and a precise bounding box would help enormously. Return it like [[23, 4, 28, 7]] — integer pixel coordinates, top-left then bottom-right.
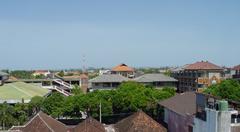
[[111, 64, 135, 78]]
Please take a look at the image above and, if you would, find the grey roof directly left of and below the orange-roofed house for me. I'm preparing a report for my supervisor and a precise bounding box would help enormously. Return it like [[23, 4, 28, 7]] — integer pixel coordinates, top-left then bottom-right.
[[89, 74, 129, 83]]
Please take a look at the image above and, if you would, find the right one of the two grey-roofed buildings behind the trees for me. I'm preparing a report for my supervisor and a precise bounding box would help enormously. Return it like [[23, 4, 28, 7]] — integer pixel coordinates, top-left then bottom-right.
[[133, 74, 178, 88]]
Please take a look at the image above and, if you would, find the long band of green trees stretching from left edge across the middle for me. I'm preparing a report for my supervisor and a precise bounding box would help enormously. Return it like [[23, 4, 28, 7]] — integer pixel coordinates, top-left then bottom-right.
[[0, 81, 175, 127]]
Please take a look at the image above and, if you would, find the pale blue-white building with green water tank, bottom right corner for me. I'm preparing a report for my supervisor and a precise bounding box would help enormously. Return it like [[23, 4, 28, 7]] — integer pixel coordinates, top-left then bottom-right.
[[193, 93, 240, 132]]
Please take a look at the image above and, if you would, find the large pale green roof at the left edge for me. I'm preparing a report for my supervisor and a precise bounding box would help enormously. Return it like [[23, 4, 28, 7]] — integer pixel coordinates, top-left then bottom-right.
[[0, 82, 49, 100]]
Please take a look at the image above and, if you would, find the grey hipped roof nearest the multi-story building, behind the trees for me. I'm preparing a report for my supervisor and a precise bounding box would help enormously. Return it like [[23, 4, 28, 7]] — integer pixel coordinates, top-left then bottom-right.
[[134, 74, 177, 82]]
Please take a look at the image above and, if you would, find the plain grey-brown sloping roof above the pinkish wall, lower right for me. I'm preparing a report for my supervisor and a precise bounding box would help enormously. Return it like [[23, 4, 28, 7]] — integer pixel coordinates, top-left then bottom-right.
[[159, 92, 196, 116]]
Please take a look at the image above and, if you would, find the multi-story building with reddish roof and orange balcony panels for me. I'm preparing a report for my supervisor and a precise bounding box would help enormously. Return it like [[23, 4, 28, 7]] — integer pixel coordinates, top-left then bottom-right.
[[173, 61, 224, 92]]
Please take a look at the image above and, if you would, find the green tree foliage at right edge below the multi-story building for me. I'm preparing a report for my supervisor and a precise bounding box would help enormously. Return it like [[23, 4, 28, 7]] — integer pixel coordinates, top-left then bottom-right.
[[204, 79, 240, 101]]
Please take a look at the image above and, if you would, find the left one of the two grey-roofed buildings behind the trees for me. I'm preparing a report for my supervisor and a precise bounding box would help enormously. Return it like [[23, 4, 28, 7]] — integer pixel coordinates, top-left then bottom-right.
[[89, 74, 129, 90]]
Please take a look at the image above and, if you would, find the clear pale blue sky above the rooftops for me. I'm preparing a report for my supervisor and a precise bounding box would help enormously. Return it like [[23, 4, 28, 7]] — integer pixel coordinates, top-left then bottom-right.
[[0, 0, 240, 69]]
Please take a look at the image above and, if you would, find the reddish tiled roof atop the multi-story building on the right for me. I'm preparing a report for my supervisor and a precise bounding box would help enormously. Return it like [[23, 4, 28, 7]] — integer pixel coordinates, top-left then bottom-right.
[[185, 61, 223, 70]]
